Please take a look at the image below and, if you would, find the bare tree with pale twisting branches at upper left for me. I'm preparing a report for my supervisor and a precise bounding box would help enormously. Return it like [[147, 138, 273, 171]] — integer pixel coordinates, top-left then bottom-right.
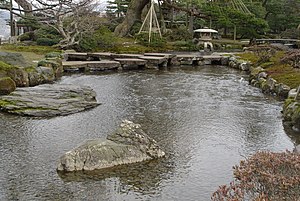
[[35, 0, 100, 49]]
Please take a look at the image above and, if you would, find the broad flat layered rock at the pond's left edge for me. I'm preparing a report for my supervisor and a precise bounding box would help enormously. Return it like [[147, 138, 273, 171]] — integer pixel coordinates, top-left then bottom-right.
[[0, 84, 99, 117]]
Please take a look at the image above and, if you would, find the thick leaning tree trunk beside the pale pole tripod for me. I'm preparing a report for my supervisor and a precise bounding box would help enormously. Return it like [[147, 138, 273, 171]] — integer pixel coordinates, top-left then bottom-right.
[[115, 0, 150, 37]]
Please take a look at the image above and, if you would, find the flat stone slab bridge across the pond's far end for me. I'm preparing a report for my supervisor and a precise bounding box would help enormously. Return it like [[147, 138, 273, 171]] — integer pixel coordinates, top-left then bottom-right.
[[62, 52, 228, 72]]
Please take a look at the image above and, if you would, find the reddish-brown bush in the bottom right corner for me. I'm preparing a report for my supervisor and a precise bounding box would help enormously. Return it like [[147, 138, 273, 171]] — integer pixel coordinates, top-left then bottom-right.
[[211, 151, 300, 201]]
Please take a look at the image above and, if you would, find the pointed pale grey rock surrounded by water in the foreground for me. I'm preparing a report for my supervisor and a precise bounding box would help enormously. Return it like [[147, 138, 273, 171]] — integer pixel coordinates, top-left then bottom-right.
[[57, 120, 165, 172]]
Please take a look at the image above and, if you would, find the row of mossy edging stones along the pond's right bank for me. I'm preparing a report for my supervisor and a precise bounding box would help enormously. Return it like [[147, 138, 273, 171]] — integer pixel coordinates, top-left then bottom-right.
[[228, 56, 300, 132]]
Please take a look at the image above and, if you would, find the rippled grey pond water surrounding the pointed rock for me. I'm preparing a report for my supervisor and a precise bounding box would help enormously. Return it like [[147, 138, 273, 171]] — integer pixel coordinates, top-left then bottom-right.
[[0, 66, 297, 201]]
